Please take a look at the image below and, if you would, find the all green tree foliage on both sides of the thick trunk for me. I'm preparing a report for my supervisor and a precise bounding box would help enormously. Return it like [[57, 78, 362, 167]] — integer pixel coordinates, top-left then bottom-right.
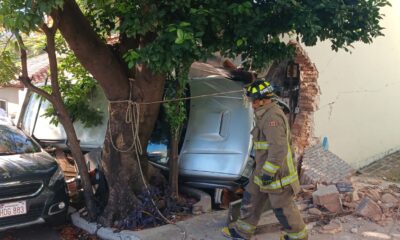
[[0, 0, 389, 125]]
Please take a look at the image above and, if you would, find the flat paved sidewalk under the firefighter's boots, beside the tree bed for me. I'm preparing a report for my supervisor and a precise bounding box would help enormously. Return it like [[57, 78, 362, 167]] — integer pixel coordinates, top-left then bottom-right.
[[72, 207, 400, 240]]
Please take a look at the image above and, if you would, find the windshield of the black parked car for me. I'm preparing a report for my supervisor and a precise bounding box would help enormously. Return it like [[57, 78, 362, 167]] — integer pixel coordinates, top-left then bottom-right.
[[0, 125, 40, 155]]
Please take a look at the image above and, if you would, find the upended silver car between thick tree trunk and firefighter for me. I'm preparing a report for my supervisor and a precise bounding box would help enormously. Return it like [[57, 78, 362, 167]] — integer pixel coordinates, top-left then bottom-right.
[[147, 77, 254, 188]]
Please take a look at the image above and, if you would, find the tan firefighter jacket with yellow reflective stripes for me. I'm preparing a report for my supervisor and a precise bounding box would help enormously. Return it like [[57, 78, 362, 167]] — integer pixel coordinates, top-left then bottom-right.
[[252, 102, 300, 194]]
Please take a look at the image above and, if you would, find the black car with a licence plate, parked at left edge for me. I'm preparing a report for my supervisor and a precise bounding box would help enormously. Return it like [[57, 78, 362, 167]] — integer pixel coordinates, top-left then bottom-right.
[[0, 123, 68, 230]]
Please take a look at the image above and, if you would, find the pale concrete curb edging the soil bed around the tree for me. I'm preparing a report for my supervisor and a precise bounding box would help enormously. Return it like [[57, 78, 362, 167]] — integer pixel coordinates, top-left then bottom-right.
[[71, 187, 211, 240]]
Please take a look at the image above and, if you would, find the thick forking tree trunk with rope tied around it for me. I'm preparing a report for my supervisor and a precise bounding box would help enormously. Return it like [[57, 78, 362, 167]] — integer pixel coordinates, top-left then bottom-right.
[[54, 0, 165, 226]]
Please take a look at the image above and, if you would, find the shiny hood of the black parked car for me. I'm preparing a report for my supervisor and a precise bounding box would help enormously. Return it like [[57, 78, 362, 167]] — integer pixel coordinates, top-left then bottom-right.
[[0, 152, 58, 182]]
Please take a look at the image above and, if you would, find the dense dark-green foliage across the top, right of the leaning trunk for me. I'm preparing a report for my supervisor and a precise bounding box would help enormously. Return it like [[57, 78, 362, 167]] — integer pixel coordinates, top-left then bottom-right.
[[83, 0, 389, 72]]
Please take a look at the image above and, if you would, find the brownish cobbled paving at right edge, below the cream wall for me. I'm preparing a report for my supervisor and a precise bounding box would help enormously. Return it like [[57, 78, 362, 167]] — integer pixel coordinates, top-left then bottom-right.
[[360, 151, 400, 182]]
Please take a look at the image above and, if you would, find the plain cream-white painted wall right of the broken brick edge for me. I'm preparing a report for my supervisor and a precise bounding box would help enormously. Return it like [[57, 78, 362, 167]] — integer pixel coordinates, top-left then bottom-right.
[[306, 0, 400, 168]]
